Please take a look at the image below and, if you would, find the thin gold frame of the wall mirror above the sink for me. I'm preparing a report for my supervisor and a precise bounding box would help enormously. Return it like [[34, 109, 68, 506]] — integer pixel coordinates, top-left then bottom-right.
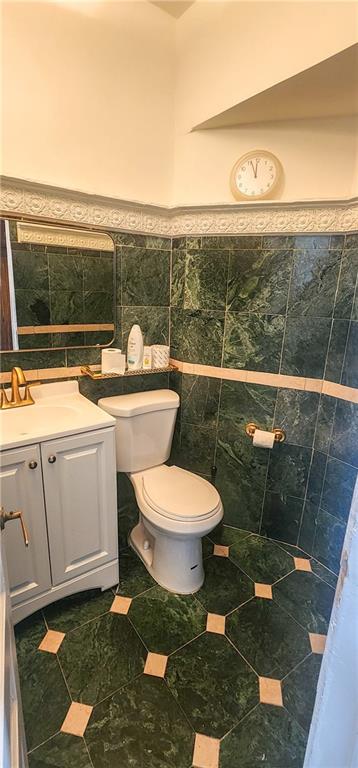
[[0, 215, 117, 355]]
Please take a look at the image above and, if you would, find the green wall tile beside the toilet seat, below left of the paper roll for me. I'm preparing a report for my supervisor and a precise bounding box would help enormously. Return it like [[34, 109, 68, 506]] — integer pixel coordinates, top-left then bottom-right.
[[216, 435, 269, 531]]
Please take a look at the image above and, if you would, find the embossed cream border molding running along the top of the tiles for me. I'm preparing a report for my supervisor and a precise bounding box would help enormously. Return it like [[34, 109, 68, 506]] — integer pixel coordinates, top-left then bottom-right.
[[0, 176, 358, 237]]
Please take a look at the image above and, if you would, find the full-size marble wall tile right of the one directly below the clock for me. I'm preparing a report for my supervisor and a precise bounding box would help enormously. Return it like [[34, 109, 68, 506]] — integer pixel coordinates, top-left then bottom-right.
[[288, 249, 341, 317]]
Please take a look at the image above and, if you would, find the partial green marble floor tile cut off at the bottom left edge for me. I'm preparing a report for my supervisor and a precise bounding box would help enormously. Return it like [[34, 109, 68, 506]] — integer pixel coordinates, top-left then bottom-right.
[[29, 733, 92, 768]]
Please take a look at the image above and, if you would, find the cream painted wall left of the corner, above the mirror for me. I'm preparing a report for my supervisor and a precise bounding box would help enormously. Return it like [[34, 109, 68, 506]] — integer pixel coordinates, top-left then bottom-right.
[[2, 0, 175, 203]]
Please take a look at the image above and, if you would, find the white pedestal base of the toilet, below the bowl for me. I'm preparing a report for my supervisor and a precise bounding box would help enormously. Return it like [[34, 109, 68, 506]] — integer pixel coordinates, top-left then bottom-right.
[[128, 515, 205, 595]]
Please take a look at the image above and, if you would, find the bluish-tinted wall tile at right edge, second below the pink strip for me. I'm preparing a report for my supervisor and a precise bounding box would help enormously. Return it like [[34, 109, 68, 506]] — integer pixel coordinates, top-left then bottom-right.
[[321, 458, 357, 523]]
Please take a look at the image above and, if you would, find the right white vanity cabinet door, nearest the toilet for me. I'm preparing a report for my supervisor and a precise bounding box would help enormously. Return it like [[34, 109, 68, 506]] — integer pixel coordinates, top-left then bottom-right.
[[41, 428, 117, 586]]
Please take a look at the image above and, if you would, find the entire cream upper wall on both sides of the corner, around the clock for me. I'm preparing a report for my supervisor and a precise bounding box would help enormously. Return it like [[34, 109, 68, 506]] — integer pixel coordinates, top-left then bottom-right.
[[2, 0, 358, 205]]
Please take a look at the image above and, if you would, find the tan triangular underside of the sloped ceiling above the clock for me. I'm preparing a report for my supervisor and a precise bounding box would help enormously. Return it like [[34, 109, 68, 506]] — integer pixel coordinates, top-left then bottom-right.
[[195, 44, 358, 130]]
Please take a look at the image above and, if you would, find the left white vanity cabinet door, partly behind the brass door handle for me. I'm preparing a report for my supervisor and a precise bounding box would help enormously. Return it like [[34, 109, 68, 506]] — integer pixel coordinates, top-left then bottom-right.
[[0, 445, 51, 605]]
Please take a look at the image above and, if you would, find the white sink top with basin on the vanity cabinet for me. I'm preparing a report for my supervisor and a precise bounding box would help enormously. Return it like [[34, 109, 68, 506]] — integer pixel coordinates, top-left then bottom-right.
[[0, 381, 115, 448]]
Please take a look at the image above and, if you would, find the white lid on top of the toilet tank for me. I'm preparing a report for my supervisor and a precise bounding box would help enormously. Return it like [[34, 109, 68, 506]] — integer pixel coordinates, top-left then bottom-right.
[[98, 389, 179, 418]]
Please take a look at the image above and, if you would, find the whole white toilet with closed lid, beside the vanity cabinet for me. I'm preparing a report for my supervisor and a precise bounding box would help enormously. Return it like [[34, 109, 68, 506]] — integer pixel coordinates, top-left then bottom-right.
[[98, 389, 223, 595]]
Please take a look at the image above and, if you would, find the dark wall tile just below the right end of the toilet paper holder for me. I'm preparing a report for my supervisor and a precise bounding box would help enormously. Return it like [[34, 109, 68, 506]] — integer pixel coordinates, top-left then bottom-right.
[[267, 443, 311, 499]]
